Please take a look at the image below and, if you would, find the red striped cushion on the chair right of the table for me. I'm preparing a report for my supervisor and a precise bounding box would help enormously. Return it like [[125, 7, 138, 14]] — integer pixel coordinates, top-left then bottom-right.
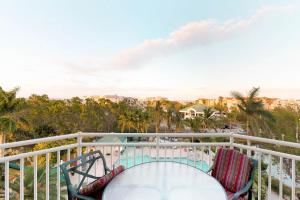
[[212, 148, 252, 193]]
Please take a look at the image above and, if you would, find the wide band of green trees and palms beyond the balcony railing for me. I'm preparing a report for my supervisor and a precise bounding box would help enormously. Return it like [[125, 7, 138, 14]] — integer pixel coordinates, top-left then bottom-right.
[[0, 87, 300, 198]]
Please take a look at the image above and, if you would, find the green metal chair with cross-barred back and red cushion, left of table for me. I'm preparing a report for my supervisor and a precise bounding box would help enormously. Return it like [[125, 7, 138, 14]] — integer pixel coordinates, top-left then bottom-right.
[[60, 151, 124, 200]]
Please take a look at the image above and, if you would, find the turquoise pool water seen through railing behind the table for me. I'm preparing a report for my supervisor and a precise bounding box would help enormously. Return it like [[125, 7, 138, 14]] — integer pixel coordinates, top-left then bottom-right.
[[114, 155, 210, 172]]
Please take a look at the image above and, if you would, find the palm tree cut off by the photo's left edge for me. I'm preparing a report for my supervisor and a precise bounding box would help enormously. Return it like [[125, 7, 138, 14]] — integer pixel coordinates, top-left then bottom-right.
[[0, 87, 26, 157]]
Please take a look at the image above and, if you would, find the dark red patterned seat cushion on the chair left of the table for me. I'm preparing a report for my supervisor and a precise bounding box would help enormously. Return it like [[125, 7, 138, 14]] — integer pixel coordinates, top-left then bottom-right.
[[79, 165, 125, 200]]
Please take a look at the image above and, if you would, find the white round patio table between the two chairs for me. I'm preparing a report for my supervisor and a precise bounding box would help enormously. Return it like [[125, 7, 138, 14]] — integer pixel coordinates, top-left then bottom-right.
[[102, 162, 227, 200]]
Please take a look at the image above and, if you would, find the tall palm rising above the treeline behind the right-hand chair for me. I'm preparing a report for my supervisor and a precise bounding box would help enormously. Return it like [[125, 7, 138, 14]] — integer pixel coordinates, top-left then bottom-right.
[[232, 87, 275, 135]]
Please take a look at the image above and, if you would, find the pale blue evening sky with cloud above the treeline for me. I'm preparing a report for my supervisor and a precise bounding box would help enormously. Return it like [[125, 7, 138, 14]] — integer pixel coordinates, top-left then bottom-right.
[[0, 0, 300, 100]]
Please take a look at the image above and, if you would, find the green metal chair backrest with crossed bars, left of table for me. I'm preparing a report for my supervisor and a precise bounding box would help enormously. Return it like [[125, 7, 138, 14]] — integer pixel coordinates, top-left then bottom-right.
[[60, 151, 110, 199]]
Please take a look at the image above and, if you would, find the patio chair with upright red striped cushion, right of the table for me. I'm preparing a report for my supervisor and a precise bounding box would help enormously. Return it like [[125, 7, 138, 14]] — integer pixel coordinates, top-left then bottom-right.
[[208, 148, 257, 200]]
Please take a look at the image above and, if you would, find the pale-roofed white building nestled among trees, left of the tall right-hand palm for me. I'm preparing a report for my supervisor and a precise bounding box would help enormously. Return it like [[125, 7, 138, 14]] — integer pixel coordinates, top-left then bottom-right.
[[179, 104, 220, 119]]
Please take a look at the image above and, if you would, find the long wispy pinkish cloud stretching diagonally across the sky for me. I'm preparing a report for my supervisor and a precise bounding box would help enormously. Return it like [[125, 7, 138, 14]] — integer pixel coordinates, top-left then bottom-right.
[[64, 5, 298, 72]]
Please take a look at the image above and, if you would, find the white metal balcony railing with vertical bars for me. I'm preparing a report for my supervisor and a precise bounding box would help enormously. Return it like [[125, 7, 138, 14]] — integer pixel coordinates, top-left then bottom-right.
[[0, 132, 300, 200]]
